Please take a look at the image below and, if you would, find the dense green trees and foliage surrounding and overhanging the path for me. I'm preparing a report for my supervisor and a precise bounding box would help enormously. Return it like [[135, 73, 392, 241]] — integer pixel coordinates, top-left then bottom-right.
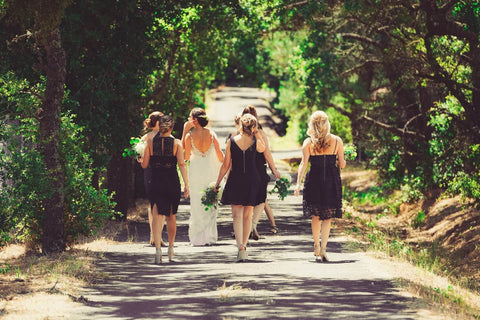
[[0, 0, 480, 251]]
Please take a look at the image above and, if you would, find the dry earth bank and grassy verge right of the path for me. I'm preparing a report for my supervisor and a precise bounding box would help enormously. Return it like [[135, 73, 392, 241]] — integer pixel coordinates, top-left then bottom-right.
[[342, 167, 480, 319]]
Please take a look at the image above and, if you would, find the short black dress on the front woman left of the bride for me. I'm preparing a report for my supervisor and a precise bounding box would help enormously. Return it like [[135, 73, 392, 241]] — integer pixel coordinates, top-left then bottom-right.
[[144, 133, 181, 216]]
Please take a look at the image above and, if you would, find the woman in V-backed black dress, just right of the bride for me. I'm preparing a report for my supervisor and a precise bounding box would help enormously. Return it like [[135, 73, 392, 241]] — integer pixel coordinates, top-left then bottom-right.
[[215, 114, 265, 261]]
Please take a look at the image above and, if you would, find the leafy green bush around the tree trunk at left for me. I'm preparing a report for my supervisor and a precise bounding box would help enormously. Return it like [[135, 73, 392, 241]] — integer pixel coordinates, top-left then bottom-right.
[[0, 75, 114, 246]]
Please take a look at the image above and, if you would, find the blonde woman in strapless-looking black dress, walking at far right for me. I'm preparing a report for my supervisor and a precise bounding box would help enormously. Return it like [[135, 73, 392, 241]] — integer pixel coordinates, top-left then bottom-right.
[[295, 111, 346, 261]]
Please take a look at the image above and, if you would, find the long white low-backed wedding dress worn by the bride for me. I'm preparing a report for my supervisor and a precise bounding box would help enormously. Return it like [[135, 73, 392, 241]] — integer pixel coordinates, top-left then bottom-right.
[[188, 136, 221, 246]]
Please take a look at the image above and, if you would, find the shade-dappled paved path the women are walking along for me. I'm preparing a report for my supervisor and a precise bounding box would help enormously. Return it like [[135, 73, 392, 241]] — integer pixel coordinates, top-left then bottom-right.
[[68, 88, 454, 319]]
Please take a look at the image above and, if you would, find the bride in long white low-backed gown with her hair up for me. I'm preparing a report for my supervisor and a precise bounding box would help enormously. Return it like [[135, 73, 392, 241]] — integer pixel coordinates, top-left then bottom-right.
[[183, 108, 223, 246]]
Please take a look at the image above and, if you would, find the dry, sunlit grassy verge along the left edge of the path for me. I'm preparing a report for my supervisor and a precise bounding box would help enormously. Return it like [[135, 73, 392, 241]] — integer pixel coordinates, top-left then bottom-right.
[[0, 218, 125, 319]]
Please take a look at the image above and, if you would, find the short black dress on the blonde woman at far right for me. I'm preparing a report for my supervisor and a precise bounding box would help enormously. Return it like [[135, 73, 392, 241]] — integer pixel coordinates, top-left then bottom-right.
[[303, 141, 342, 220]]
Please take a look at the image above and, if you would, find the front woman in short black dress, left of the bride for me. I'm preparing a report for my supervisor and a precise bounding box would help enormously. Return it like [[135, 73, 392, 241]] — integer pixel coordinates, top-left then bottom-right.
[[142, 116, 189, 264]]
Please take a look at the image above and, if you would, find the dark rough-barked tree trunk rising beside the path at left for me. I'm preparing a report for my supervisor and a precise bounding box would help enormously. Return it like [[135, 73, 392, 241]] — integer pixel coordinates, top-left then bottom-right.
[[39, 27, 66, 254]]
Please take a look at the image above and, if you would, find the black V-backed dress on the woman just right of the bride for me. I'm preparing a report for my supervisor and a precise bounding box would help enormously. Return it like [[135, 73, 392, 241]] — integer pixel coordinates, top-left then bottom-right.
[[221, 137, 260, 206]]
